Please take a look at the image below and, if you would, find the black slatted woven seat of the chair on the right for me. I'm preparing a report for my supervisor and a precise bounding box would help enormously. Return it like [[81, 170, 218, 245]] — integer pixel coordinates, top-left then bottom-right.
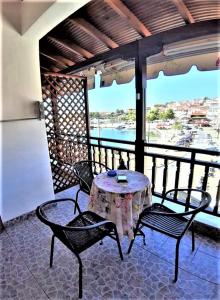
[[141, 203, 188, 238]]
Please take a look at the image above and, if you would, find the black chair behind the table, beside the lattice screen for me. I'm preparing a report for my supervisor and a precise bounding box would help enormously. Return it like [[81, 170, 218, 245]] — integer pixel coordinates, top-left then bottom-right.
[[73, 160, 111, 212]]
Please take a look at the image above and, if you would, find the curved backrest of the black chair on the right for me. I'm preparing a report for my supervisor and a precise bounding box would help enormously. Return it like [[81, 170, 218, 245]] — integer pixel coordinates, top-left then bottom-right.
[[162, 188, 211, 215]]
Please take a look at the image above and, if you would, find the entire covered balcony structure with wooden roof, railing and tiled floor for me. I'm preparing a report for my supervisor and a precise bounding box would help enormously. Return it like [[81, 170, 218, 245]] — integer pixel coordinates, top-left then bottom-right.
[[0, 0, 220, 300]]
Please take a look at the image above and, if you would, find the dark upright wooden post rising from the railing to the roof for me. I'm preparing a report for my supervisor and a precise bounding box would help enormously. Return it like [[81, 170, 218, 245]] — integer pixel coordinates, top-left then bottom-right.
[[135, 41, 147, 173]]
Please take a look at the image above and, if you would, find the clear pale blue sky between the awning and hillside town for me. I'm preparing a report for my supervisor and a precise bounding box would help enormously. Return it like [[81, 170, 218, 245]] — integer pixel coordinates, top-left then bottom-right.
[[89, 67, 220, 112]]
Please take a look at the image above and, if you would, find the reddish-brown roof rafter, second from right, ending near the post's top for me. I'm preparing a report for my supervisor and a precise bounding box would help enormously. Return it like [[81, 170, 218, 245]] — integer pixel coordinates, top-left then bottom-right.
[[104, 0, 151, 37]]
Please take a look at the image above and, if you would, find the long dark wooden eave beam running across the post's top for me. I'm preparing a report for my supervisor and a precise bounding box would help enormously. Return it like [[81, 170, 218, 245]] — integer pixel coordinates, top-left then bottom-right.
[[61, 19, 219, 74]]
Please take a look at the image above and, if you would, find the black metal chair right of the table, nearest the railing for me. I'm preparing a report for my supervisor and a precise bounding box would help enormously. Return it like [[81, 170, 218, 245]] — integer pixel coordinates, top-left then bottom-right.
[[128, 189, 211, 282]]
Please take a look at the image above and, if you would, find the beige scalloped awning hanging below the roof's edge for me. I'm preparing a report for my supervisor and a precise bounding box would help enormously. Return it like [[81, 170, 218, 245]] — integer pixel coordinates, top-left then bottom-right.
[[75, 35, 220, 89]]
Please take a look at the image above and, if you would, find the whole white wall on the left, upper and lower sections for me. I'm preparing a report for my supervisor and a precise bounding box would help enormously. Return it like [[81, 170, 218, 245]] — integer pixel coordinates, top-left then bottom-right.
[[0, 0, 88, 222]]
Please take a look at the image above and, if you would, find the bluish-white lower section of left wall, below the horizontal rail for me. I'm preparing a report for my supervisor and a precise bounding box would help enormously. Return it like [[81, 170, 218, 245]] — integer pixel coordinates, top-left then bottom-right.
[[1, 120, 54, 221]]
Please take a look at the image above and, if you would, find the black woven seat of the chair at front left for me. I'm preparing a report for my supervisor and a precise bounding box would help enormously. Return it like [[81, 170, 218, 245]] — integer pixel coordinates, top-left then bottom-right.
[[65, 211, 112, 253]]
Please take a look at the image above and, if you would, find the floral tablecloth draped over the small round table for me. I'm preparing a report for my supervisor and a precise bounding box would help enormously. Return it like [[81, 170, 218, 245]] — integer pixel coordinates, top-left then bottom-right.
[[88, 170, 151, 239]]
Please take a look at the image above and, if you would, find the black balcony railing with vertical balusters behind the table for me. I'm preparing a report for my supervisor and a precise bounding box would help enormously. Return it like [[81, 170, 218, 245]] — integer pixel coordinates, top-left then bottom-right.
[[89, 137, 220, 216]]
